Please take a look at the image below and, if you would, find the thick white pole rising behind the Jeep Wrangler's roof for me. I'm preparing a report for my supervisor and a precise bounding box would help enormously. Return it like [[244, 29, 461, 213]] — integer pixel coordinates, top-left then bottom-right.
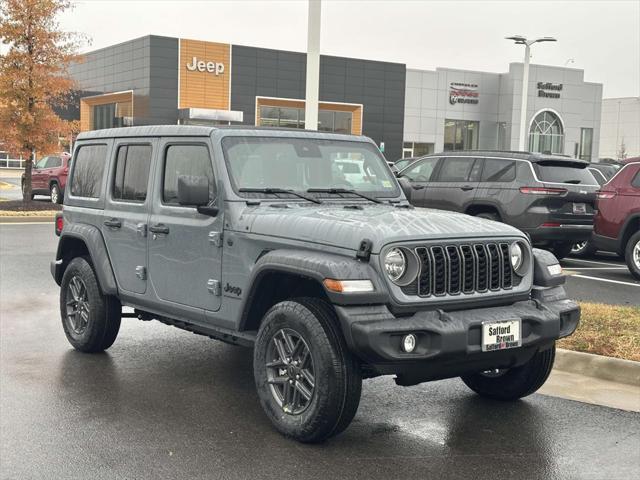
[[304, 0, 320, 130]]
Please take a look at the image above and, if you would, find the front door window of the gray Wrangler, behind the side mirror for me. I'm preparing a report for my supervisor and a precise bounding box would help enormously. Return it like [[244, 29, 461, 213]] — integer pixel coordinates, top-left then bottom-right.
[[162, 145, 216, 205]]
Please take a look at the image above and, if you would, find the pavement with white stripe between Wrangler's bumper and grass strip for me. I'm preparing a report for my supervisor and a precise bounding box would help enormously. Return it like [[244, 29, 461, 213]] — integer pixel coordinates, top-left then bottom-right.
[[560, 253, 640, 305]]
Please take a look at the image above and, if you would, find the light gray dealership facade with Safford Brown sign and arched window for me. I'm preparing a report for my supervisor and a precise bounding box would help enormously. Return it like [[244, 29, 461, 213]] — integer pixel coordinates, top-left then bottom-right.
[[403, 63, 602, 160]]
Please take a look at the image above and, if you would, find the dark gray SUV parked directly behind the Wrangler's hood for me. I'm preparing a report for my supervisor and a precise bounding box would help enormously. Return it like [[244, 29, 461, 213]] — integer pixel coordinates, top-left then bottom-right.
[[399, 151, 599, 258]]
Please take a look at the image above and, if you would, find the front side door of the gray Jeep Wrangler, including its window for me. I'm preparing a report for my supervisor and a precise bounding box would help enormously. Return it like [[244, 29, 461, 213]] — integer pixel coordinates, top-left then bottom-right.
[[148, 137, 223, 314]]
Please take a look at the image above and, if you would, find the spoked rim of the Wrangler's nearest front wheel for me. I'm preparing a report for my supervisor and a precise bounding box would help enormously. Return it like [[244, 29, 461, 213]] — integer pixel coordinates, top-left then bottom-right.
[[266, 328, 315, 415]]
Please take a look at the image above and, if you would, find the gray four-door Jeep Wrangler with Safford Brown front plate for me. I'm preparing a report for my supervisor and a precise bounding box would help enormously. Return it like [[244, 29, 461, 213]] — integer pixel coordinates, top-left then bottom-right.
[[51, 126, 580, 442]]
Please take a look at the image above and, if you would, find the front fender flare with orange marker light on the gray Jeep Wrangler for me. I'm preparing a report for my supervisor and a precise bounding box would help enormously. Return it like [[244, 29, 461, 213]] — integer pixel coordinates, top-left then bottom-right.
[[239, 249, 388, 331]]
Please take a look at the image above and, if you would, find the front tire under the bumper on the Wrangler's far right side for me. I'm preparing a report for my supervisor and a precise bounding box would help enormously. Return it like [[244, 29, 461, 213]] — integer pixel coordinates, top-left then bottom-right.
[[460, 343, 556, 401]]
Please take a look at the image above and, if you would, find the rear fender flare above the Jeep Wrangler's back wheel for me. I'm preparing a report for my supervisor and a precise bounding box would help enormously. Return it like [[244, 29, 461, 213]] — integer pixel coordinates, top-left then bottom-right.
[[52, 223, 118, 295]]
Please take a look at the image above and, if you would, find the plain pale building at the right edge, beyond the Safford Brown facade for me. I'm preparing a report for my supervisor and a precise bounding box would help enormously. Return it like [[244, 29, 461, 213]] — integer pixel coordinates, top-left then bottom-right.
[[600, 97, 640, 159]]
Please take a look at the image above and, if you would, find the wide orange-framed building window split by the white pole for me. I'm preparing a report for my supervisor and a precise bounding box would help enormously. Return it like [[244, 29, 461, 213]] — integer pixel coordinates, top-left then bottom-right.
[[260, 105, 353, 134]]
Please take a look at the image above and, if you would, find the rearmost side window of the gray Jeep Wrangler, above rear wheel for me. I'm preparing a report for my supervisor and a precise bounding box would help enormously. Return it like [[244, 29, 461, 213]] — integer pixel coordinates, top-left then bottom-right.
[[71, 145, 107, 198]]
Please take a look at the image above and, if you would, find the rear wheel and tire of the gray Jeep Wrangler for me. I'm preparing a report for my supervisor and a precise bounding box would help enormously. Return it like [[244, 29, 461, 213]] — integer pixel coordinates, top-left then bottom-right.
[[60, 257, 122, 353]]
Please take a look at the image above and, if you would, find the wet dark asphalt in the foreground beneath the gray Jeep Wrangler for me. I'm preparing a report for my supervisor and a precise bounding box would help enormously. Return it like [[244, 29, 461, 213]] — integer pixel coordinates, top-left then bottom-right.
[[0, 225, 640, 479]]
